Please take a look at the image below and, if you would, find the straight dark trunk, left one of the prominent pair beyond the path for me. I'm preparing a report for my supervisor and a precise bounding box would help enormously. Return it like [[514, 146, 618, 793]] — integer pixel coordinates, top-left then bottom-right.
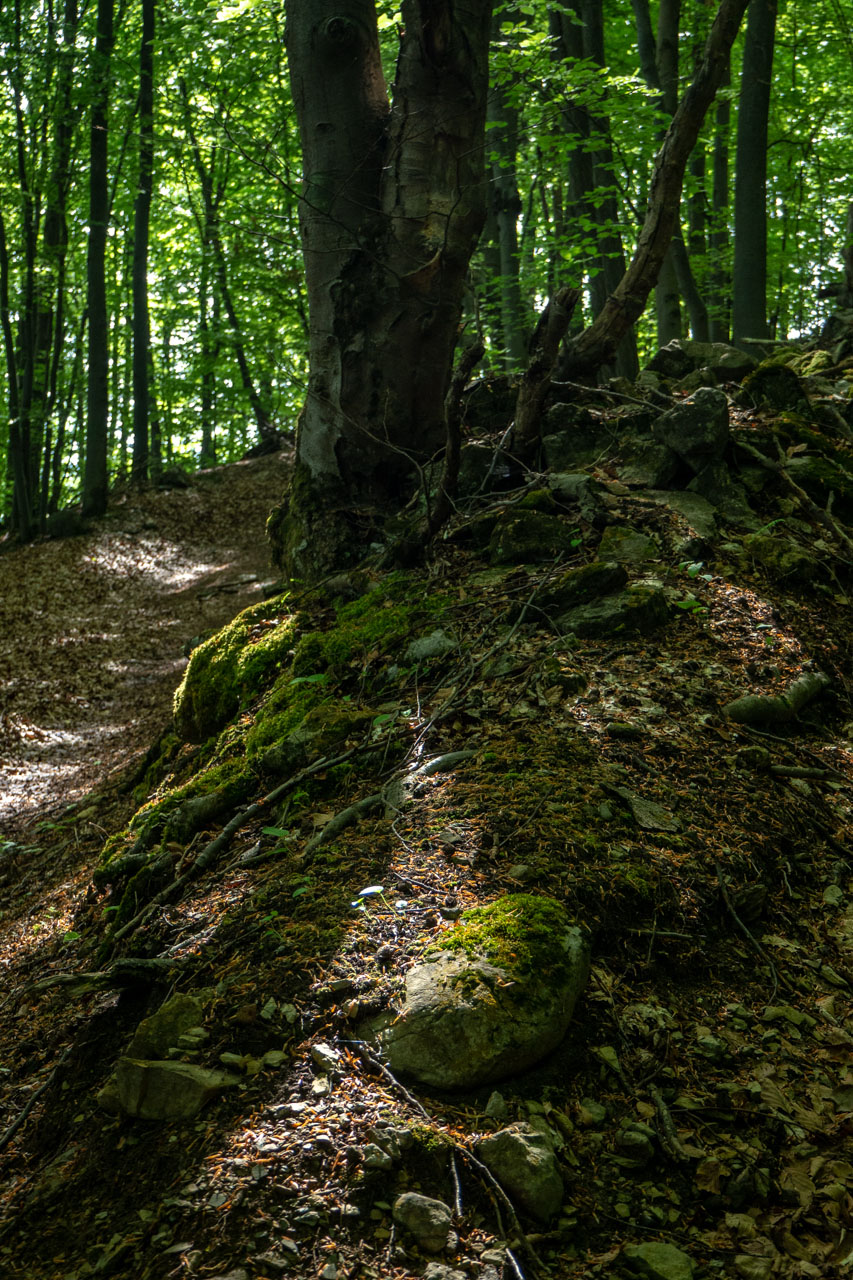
[[83, 0, 114, 516]]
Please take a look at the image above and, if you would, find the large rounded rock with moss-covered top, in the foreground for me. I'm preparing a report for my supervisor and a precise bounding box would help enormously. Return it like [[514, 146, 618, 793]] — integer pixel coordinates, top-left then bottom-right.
[[378, 893, 589, 1089]]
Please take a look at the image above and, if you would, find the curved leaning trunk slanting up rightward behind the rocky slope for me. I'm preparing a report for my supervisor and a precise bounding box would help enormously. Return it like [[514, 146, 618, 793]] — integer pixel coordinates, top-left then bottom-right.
[[561, 0, 748, 374]]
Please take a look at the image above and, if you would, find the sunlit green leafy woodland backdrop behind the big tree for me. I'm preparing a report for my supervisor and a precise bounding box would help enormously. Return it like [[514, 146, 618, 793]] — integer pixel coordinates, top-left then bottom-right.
[[0, 0, 853, 538]]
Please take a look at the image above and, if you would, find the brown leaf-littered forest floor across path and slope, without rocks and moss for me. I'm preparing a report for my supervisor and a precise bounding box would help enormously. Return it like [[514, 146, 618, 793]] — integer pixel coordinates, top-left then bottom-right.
[[0, 422, 853, 1280]]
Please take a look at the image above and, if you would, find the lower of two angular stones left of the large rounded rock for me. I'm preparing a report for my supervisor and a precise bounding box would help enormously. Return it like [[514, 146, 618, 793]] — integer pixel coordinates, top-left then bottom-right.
[[115, 1057, 240, 1120]]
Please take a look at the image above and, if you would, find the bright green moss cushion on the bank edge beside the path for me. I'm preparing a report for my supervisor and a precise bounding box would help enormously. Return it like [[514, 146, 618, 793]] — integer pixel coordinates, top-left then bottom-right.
[[174, 596, 297, 742]]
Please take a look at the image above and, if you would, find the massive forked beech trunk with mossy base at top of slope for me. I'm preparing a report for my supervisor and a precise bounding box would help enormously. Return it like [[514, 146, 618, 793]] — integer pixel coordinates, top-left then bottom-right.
[[269, 0, 492, 576]]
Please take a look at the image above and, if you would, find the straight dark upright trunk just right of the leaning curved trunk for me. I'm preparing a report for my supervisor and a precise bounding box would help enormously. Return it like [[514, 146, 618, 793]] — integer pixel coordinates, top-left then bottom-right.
[[731, 0, 776, 343]]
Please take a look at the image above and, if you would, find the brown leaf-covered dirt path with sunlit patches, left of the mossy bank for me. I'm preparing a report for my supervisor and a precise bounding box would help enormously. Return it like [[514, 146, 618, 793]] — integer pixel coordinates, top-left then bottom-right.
[[0, 453, 288, 838]]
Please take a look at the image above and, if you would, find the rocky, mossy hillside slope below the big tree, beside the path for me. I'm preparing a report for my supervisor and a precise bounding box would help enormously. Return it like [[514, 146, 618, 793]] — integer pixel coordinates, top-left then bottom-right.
[[0, 363, 853, 1280]]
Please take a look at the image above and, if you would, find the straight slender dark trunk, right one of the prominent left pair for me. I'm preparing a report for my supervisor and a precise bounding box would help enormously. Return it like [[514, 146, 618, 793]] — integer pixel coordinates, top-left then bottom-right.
[[131, 0, 156, 484]]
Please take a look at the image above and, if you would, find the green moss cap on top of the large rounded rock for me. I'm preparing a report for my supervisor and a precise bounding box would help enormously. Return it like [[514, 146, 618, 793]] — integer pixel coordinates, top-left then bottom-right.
[[427, 893, 569, 980]]
